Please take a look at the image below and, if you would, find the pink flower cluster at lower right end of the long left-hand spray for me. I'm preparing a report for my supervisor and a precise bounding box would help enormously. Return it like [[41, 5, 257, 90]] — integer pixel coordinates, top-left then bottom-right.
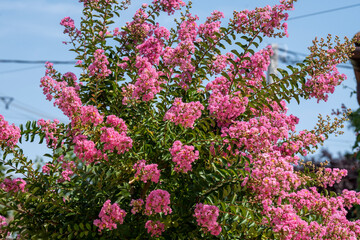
[[100, 127, 132, 154]]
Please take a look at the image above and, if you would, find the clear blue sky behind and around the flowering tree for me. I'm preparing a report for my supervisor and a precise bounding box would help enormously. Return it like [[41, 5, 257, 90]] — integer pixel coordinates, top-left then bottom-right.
[[0, 0, 360, 160]]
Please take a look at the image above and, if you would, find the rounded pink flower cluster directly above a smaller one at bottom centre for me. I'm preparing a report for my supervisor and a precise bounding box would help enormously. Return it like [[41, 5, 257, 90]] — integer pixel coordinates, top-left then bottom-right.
[[145, 189, 172, 215]]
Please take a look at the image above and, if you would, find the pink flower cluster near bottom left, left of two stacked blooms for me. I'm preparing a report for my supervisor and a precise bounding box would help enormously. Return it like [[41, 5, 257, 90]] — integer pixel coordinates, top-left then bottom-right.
[[94, 200, 126, 232]]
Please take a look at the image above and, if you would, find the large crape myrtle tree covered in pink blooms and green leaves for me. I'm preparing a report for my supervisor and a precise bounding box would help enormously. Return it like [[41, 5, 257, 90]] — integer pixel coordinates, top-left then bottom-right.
[[0, 0, 360, 239]]
